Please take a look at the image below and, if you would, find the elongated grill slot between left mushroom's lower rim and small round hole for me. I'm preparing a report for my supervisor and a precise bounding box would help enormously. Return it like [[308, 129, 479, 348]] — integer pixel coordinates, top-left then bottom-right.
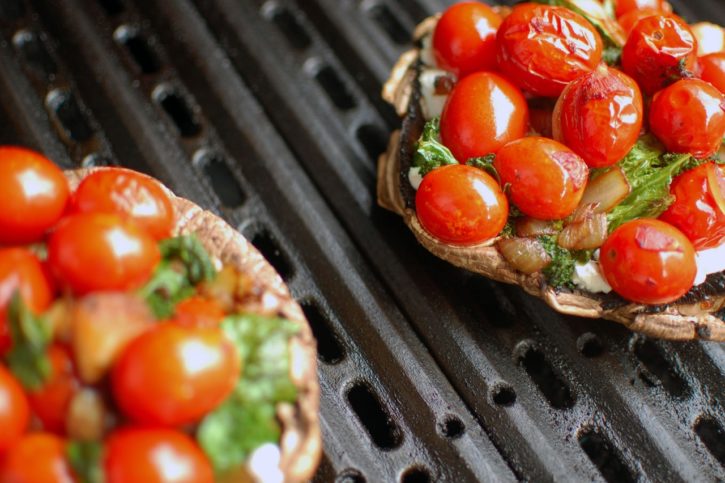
[[347, 382, 403, 450]]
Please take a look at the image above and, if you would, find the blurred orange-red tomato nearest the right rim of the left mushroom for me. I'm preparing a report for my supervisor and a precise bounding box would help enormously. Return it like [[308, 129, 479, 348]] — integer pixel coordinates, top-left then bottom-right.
[[112, 323, 241, 426]]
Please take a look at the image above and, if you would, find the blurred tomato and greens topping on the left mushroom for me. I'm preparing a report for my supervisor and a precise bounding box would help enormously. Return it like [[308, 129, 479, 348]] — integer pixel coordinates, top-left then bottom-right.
[[0, 147, 297, 483]]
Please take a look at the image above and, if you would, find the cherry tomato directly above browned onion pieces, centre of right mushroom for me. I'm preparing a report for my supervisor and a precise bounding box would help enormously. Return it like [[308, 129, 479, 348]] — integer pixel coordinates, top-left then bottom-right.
[[493, 137, 589, 220]]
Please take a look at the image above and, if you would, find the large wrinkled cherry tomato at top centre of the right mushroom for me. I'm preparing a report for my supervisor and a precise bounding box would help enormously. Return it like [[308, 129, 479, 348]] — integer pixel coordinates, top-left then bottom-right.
[[496, 3, 602, 97]]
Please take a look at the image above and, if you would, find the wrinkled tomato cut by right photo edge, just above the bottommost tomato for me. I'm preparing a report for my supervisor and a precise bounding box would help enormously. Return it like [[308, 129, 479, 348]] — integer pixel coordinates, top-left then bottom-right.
[[660, 163, 725, 250]]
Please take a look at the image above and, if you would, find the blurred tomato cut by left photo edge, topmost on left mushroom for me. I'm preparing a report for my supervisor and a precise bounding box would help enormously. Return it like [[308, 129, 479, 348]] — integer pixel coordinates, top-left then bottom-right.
[[0, 146, 69, 244]]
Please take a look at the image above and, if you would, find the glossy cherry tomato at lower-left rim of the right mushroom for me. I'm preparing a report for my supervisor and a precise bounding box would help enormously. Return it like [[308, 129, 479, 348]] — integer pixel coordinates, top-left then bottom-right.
[[415, 164, 508, 245]]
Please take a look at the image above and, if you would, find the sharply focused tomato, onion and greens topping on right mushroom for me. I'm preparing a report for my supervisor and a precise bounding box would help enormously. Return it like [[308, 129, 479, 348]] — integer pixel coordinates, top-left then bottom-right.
[[408, 0, 725, 304]]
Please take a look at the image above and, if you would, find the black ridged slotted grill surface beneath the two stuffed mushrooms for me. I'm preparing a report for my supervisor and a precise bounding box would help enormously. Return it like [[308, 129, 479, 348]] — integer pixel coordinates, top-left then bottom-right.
[[0, 0, 725, 483]]
